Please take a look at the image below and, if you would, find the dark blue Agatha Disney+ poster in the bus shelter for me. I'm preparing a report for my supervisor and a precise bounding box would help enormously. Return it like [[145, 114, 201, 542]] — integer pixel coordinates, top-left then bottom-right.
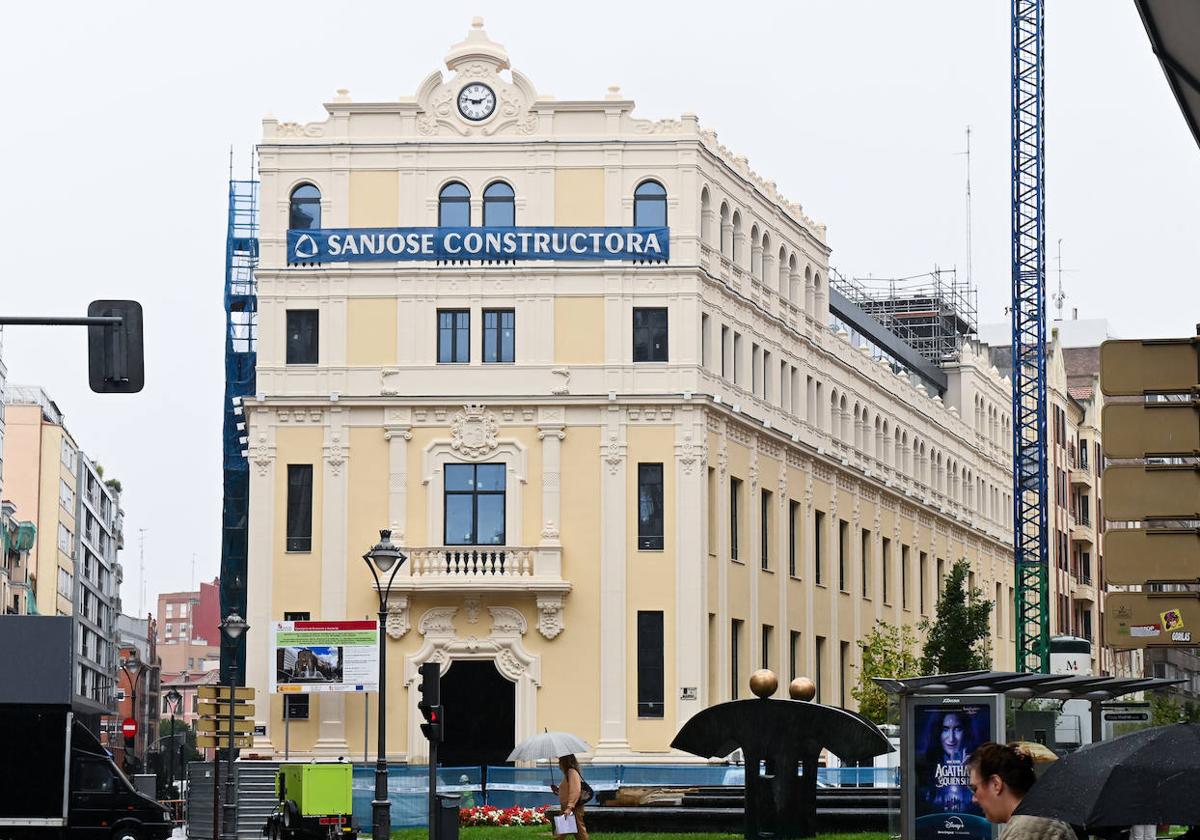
[[913, 703, 995, 840]]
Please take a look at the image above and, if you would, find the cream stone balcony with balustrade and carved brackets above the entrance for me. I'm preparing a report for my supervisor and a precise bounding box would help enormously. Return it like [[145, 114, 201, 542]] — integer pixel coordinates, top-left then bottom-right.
[[376, 545, 571, 638]]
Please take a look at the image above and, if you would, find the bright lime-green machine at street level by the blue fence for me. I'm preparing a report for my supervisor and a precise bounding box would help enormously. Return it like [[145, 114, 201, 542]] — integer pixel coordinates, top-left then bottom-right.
[[263, 763, 359, 840]]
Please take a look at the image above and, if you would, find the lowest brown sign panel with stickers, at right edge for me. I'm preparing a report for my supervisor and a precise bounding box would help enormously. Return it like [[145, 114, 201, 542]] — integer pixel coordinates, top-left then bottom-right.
[[1104, 592, 1200, 650]]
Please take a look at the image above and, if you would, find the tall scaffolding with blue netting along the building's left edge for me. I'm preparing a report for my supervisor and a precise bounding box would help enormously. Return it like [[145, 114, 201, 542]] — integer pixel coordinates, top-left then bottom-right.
[[221, 178, 258, 684]]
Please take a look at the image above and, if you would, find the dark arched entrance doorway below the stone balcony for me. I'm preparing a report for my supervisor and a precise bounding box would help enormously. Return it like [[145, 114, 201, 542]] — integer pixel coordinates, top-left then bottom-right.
[[438, 659, 516, 767]]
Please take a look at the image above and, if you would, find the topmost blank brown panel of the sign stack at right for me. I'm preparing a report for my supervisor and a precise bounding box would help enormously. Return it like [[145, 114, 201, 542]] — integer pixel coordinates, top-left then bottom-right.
[[1100, 338, 1200, 397]]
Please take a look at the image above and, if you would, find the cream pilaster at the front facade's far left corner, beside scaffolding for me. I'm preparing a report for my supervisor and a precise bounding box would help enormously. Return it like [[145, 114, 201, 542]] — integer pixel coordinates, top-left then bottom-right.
[[245, 408, 283, 752]]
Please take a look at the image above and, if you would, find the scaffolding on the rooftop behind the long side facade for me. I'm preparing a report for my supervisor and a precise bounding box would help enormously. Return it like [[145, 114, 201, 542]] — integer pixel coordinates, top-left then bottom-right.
[[829, 268, 978, 365]]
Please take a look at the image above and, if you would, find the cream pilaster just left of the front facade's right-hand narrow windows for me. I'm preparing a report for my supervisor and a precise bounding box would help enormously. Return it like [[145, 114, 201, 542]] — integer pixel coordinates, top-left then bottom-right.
[[594, 406, 630, 758]]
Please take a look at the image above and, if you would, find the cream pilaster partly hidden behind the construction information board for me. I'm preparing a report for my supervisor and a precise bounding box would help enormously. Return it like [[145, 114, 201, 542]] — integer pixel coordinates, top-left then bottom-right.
[[312, 407, 350, 756]]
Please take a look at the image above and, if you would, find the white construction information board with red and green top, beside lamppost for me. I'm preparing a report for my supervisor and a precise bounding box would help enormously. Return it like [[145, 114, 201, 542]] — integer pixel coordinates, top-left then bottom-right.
[[271, 622, 379, 694]]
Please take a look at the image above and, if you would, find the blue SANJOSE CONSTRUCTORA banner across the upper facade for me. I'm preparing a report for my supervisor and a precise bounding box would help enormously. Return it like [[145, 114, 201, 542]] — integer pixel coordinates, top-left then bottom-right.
[[288, 228, 671, 263]]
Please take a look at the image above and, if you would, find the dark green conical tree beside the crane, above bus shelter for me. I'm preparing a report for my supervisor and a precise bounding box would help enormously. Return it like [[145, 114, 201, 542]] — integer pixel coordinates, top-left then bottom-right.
[[920, 557, 994, 674]]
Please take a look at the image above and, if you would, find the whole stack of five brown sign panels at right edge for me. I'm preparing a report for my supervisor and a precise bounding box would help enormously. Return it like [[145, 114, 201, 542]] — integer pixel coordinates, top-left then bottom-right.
[[1100, 329, 1200, 648]]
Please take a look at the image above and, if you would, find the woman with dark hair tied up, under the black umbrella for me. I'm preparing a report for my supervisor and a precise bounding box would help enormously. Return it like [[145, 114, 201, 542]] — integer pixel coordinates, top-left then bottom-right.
[[967, 742, 1075, 840]]
